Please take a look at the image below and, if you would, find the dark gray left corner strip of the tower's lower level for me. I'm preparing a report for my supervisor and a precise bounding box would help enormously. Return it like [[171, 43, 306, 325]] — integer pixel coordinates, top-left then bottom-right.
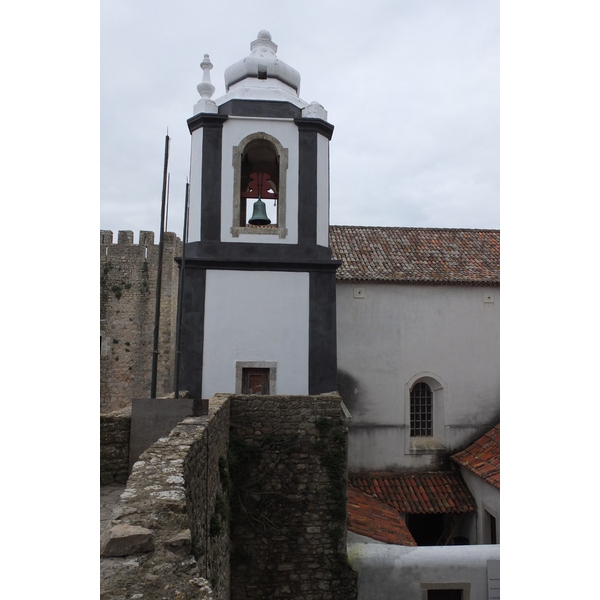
[[180, 266, 206, 399]]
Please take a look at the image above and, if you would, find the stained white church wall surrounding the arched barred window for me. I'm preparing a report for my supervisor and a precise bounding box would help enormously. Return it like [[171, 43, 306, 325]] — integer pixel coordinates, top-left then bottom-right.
[[337, 283, 500, 469]]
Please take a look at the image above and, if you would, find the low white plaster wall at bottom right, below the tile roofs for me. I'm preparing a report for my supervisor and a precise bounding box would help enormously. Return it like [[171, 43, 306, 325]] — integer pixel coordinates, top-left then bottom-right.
[[348, 543, 500, 600]]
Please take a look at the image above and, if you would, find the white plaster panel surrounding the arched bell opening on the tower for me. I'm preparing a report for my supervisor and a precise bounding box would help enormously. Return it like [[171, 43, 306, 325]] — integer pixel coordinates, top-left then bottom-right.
[[221, 117, 298, 244]]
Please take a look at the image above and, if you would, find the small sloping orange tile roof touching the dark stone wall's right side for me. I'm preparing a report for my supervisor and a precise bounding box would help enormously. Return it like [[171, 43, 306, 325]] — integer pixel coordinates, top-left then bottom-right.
[[348, 485, 417, 546]]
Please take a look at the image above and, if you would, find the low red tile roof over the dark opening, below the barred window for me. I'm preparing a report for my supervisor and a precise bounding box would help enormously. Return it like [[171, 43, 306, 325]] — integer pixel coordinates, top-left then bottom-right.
[[348, 471, 475, 514]]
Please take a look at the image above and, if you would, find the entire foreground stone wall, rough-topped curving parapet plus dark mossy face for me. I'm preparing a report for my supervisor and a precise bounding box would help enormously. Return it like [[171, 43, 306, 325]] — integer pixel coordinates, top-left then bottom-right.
[[101, 394, 357, 600]]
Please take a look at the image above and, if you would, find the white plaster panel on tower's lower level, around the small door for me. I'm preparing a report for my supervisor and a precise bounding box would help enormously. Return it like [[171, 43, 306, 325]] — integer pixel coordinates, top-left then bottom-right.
[[202, 270, 309, 398]]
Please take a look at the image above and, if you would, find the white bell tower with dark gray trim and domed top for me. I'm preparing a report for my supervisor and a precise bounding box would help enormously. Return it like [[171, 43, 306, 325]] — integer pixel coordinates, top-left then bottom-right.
[[180, 31, 340, 398]]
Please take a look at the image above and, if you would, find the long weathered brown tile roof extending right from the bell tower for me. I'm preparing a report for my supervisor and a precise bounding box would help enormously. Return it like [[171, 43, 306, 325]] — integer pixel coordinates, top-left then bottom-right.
[[329, 225, 500, 285]]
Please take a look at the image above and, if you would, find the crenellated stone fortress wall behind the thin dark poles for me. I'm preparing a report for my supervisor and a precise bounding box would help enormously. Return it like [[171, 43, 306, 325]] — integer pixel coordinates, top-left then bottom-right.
[[100, 231, 182, 413]]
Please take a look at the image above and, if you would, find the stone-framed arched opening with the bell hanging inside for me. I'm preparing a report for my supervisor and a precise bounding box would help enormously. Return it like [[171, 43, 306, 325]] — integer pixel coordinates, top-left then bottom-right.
[[231, 131, 288, 238]]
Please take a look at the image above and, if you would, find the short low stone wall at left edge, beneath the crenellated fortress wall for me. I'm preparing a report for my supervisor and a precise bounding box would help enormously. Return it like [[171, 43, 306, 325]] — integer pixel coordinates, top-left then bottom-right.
[[100, 408, 131, 485]]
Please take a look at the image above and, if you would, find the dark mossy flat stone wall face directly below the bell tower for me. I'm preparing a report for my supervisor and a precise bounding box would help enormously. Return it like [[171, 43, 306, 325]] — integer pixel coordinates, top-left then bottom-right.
[[229, 394, 357, 600]]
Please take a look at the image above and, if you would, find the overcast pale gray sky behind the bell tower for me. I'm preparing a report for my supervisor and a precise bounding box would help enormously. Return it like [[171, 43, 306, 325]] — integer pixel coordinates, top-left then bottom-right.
[[100, 0, 500, 242]]
